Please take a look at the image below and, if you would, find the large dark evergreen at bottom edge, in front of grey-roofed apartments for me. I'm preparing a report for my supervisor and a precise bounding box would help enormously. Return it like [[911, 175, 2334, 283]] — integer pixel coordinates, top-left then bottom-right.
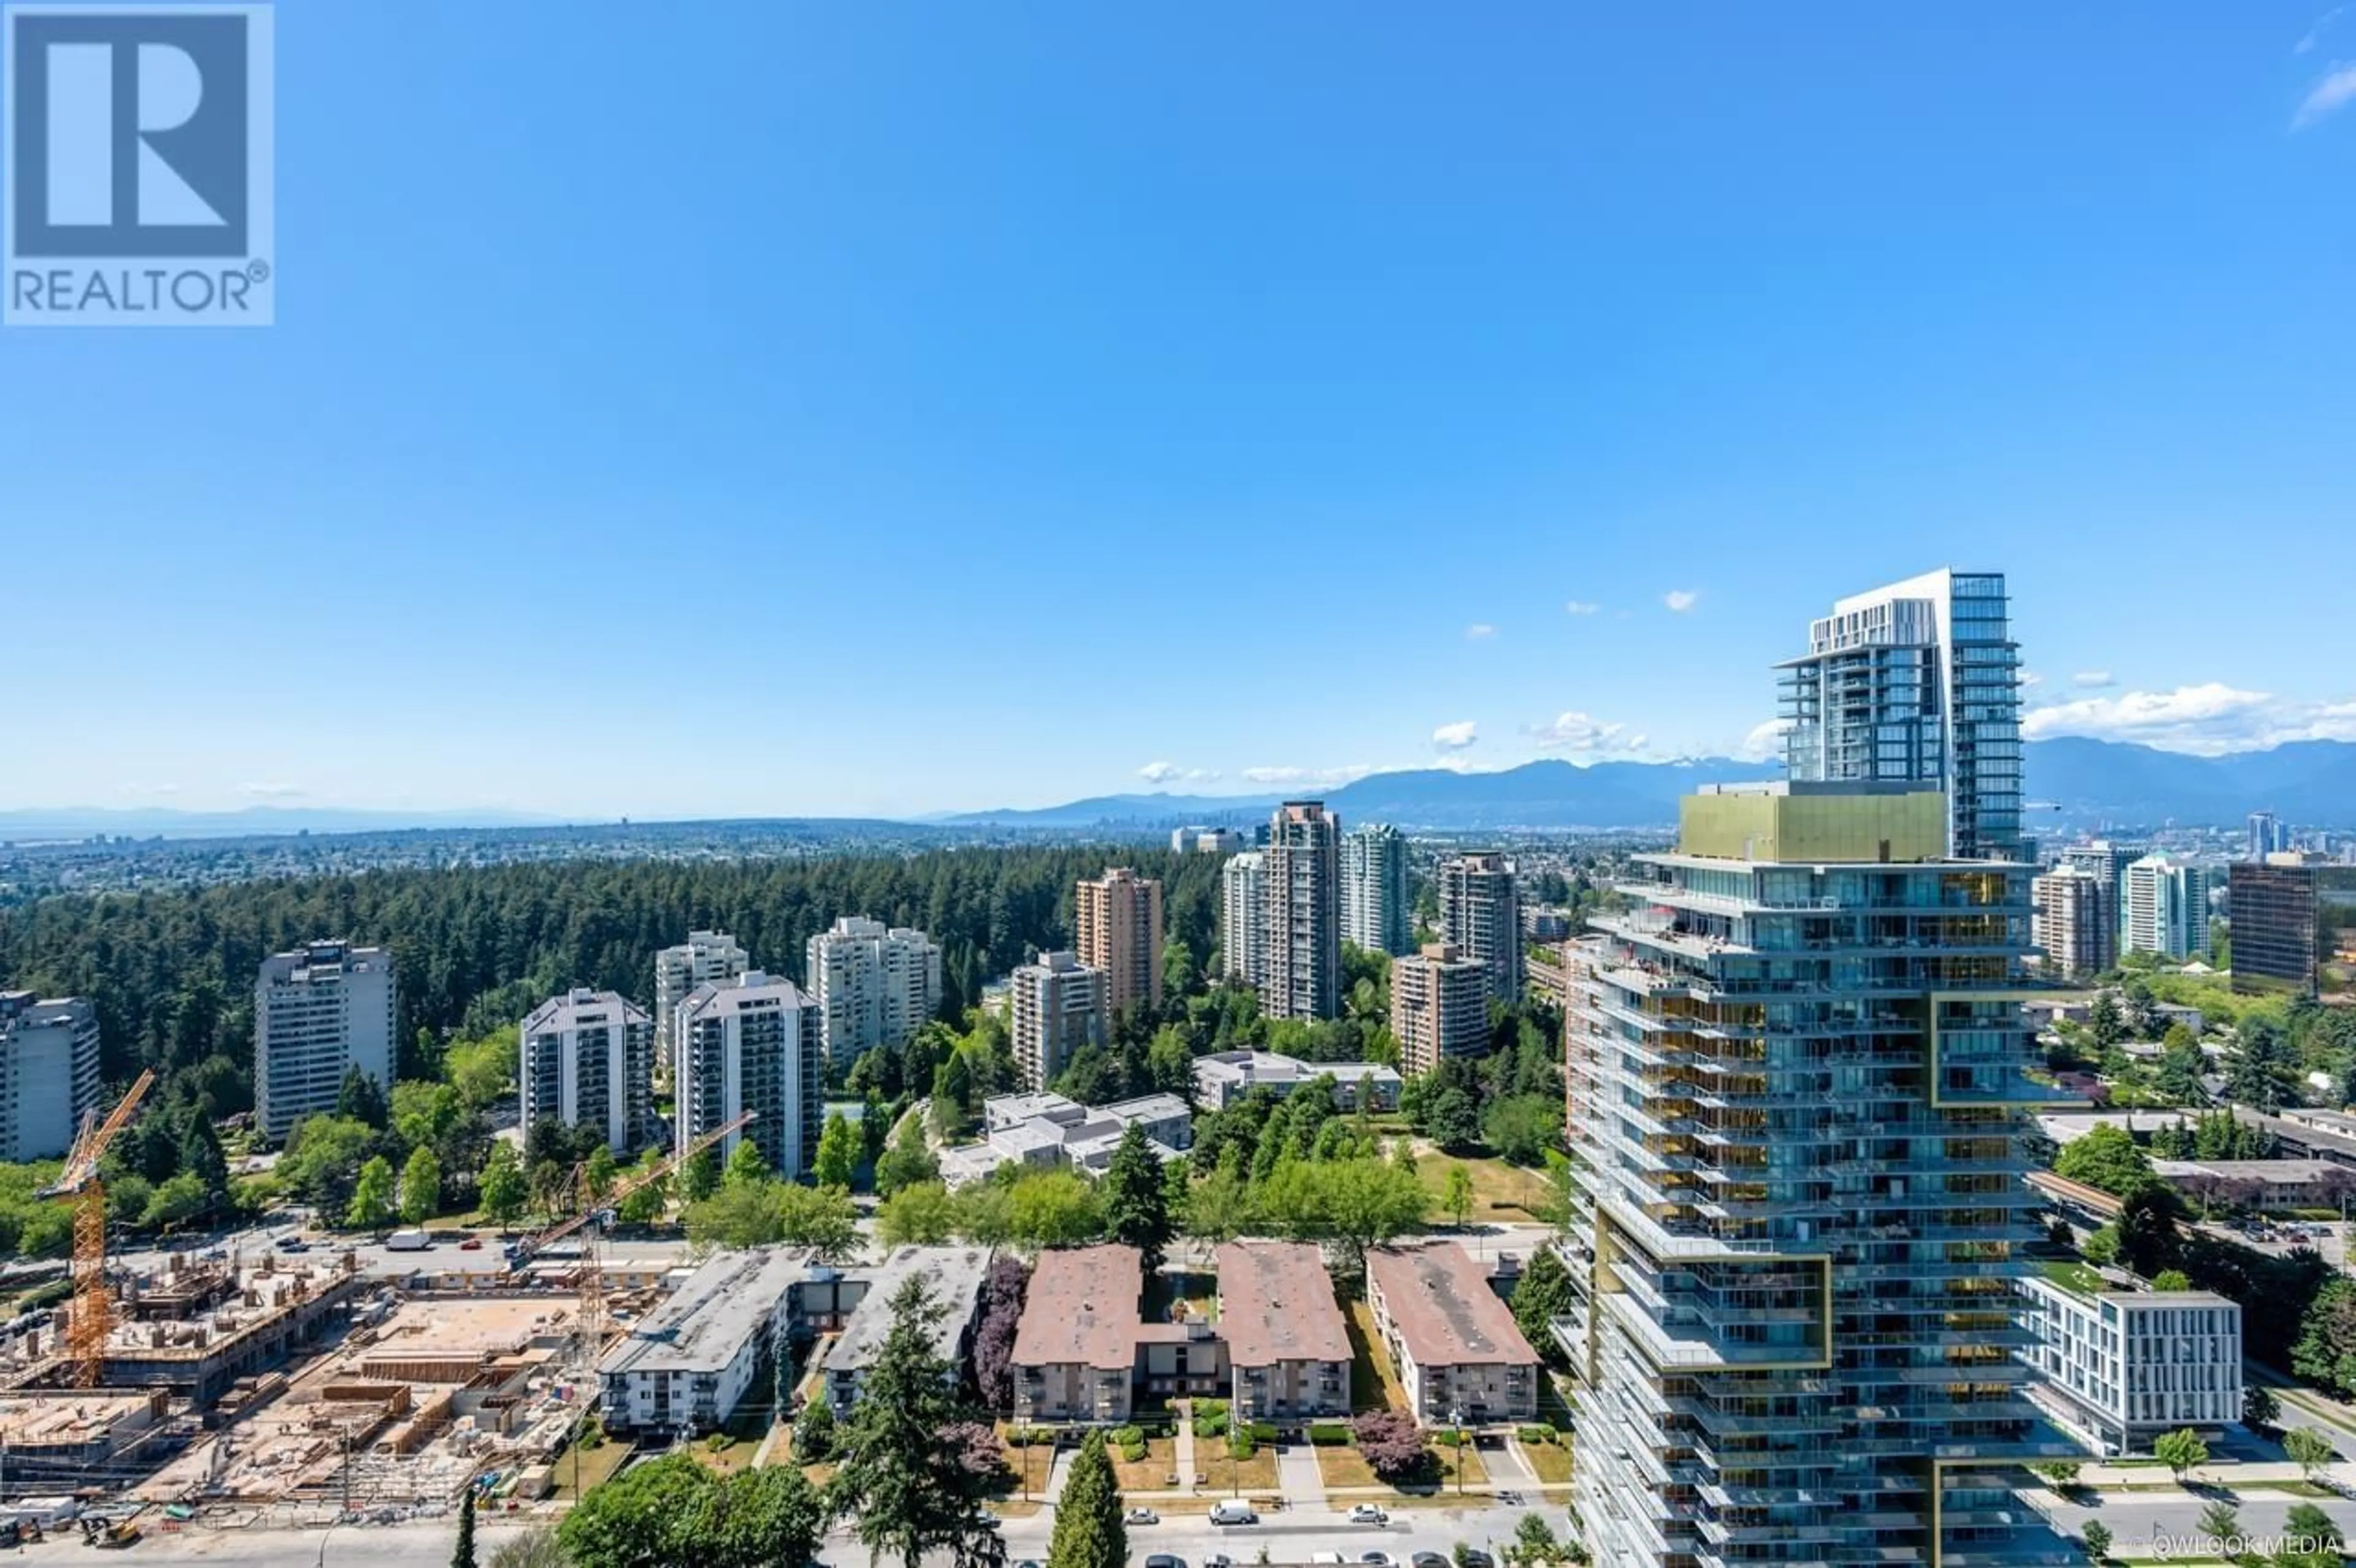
[[832, 1278, 1004, 1568]]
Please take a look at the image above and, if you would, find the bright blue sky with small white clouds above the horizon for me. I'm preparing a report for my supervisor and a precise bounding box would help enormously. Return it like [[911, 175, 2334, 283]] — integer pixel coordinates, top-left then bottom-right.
[[0, 0, 2356, 817]]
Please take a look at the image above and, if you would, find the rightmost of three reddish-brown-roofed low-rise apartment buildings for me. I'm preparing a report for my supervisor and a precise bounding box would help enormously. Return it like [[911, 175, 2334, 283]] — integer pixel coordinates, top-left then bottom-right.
[[1366, 1241, 1539, 1427]]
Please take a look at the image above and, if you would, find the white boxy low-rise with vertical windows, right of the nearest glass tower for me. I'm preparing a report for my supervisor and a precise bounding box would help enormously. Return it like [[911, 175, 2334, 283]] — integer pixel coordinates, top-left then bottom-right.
[[2022, 1274, 2241, 1455]]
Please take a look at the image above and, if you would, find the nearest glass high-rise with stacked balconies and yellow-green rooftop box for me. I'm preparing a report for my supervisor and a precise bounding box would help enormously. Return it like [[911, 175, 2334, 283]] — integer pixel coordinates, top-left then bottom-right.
[[1553, 782, 2078, 1568]]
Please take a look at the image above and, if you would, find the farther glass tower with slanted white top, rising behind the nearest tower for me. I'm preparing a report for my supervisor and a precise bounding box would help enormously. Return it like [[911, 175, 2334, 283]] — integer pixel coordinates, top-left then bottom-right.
[[1779, 567, 2026, 859]]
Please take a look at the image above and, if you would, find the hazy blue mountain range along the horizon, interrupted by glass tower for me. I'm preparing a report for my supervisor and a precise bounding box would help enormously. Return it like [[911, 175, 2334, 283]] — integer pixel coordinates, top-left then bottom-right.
[[940, 737, 2356, 834]]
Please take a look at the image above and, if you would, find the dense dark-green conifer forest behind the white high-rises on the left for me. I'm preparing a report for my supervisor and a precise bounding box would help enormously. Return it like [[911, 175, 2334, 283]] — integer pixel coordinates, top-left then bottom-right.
[[0, 848, 1220, 1116]]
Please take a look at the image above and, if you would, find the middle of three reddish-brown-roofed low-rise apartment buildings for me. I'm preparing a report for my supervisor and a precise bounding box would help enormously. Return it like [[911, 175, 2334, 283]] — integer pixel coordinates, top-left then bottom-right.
[[1218, 1241, 1350, 1422]]
